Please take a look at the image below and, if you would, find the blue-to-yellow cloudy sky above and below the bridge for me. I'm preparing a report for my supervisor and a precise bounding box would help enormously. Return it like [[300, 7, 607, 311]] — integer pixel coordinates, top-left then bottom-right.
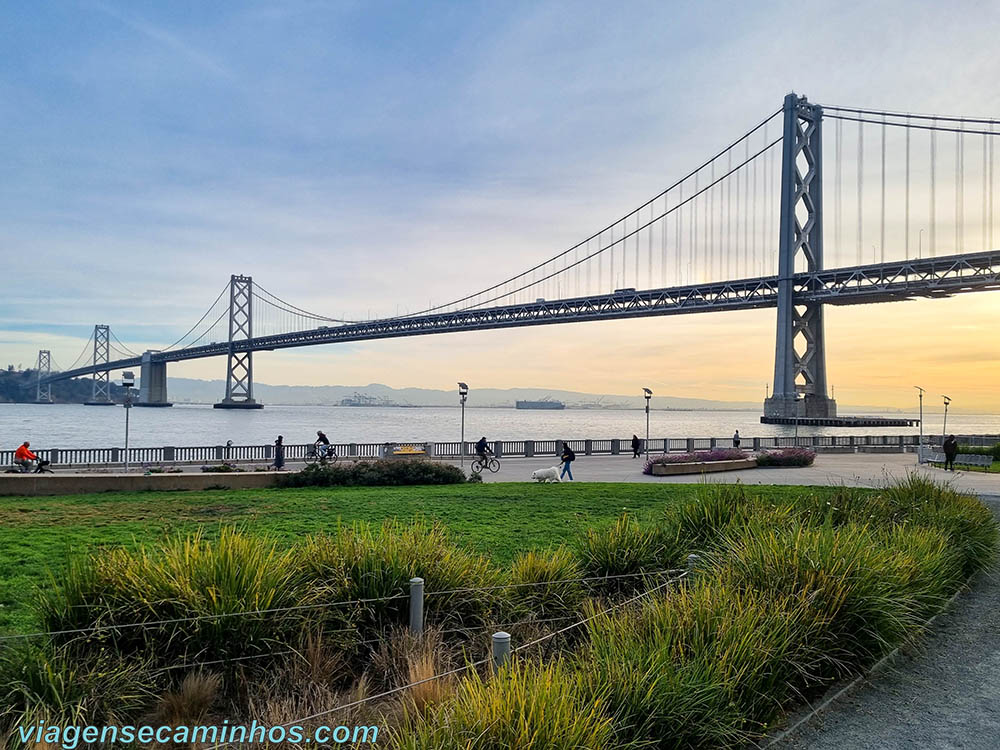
[[0, 0, 1000, 411]]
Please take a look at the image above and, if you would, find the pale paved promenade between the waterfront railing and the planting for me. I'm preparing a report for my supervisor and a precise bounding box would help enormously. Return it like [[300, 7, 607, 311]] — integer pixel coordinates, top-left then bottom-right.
[[458, 453, 1000, 495]]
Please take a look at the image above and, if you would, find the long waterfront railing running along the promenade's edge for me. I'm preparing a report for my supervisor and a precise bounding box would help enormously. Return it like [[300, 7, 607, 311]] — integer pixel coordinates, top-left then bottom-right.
[[0, 434, 1000, 466]]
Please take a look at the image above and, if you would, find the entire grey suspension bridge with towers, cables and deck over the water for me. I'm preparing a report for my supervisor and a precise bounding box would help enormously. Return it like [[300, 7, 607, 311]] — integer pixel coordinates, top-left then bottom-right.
[[29, 94, 1000, 420]]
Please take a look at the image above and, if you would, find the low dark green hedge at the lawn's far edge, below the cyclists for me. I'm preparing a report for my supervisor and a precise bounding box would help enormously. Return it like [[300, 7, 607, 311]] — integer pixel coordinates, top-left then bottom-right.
[[277, 459, 466, 487]]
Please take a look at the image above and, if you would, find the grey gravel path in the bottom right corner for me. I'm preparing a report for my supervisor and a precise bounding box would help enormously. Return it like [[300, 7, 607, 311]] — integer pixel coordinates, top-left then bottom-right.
[[772, 496, 1000, 750]]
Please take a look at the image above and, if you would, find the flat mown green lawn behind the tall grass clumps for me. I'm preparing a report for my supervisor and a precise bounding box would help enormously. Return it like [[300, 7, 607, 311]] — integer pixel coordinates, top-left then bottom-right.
[[0, 482, 829, 634]]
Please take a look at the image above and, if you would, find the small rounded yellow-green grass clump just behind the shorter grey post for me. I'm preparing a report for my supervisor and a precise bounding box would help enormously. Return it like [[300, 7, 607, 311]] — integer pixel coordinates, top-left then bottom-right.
[[510, 547, 587, 619]]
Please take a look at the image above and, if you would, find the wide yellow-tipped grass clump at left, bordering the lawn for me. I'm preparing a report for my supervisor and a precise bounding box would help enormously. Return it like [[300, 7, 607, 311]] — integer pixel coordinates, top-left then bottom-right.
[[39, 528, 308, 663]]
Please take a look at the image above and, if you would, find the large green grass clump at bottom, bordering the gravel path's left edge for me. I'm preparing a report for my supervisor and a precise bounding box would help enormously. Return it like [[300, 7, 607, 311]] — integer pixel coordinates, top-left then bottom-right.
[[579, 580, 824, 748]]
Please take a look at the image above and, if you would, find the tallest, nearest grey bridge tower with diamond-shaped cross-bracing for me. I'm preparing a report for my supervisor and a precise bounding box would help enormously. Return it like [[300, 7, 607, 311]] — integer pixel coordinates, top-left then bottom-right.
[[764, 93, 837, 417]]
